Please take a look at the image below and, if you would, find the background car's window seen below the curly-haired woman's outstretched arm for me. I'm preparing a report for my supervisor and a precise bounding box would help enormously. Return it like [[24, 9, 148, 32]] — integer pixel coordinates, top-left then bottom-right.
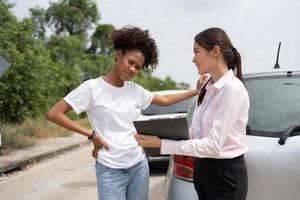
[[142, 98, 194, 115]]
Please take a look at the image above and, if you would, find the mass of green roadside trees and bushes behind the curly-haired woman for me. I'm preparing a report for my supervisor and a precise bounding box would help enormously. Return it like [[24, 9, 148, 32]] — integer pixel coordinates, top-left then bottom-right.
[[0, 0, 188, 123]]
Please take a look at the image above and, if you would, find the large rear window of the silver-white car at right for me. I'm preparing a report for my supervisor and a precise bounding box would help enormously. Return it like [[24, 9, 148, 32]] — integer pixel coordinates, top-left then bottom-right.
[[245, 75, 300, 137]]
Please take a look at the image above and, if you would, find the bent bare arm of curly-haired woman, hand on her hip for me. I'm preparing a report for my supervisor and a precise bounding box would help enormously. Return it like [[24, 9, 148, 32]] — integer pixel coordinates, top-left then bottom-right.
[[47, 100, 109, 150]]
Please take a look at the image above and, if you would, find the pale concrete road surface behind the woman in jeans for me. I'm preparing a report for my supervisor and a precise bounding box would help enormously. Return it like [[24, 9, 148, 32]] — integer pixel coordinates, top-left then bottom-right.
[[0, 146, 165, 200]]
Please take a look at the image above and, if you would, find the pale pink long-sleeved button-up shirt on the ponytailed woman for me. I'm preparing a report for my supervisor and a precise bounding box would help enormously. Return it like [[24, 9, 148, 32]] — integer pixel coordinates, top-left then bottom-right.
[[161, 70, 250, 158]]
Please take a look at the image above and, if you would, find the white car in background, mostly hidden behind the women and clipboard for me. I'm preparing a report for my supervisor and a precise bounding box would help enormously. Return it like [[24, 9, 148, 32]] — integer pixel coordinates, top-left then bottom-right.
[[137, 90, 194, 162]]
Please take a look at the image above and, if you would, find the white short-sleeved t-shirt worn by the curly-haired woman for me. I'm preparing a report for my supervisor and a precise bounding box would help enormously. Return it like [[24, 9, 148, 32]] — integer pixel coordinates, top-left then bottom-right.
[[63, 77, 154, 169]]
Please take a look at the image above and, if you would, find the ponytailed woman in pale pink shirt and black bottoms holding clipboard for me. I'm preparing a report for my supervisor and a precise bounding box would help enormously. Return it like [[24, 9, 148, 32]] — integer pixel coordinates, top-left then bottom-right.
[[135, 28, 249, 200]]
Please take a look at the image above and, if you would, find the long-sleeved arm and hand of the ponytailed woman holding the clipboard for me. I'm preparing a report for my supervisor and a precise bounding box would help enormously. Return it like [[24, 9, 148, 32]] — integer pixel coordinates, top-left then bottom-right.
[[135, 89, 248, 157]]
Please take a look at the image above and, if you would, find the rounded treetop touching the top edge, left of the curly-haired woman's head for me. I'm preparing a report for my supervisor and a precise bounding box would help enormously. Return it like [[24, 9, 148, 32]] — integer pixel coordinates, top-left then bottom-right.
[[46, 0, 100, 36]]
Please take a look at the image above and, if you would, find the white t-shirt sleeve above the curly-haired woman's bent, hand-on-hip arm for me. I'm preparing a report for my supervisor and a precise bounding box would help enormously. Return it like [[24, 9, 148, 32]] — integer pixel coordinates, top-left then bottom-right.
[[63, 81, 92, 114]]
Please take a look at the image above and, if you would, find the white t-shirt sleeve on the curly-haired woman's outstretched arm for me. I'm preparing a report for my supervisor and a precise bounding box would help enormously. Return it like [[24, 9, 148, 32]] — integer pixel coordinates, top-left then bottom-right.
[[135, 84, 154, 109]]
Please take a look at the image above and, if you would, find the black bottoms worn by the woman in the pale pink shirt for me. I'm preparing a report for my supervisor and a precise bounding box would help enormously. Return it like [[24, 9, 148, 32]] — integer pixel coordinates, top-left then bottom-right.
[[193, 155, 248, 200]]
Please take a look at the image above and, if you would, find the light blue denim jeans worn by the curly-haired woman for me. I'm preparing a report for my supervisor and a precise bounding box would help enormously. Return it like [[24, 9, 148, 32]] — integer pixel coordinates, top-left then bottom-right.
[[96, 159, 149, 200]]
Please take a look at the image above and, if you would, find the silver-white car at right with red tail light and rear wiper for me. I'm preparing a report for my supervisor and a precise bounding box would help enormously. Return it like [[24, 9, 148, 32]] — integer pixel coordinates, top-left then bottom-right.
[[164, 70, 300, 200]]
